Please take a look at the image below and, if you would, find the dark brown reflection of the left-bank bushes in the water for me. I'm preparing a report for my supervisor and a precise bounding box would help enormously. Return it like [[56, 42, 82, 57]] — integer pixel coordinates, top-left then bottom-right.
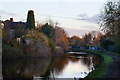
[[3, 58, 50, 78]]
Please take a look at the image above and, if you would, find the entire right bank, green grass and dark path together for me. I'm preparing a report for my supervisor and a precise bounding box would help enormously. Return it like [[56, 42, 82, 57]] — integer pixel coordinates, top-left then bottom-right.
[[83, 50, 120, 80]]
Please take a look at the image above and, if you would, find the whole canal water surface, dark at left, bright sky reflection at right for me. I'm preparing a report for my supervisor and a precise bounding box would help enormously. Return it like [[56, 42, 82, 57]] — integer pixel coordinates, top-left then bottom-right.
[[2, 54, 102, 80]]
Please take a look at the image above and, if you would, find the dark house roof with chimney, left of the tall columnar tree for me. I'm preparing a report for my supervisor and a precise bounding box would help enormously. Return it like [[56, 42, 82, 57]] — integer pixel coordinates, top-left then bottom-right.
[[3, 18, 26, 29]]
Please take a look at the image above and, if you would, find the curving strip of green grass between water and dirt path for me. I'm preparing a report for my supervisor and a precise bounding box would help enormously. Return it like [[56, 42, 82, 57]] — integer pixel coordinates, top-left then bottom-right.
[[83, 50, 113, 80]]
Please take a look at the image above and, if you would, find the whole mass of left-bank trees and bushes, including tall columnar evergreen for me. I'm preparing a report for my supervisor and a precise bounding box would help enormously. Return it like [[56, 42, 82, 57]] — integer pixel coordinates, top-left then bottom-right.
[[2, 10, 69, 60]]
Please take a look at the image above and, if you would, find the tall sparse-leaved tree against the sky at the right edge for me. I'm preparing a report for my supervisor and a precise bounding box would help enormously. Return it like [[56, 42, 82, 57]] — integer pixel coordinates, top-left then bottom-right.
[[100, 0, 120, 52]]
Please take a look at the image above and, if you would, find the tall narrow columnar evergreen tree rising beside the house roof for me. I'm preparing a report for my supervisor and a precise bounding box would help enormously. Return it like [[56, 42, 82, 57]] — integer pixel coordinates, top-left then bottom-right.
[[26, 10, 35, 30]]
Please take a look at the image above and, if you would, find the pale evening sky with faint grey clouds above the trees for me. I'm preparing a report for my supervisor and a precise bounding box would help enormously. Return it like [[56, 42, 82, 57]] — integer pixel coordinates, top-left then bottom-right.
[[0, 0, 109, 37]]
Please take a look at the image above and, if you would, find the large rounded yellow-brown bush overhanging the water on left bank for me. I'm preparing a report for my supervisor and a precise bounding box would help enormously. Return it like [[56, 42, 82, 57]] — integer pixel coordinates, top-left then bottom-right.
[[23, 30, 55, 57]]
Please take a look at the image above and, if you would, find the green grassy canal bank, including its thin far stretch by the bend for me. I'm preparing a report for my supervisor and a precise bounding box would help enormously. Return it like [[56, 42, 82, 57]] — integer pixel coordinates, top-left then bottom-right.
[[65, 49, 113, 80]]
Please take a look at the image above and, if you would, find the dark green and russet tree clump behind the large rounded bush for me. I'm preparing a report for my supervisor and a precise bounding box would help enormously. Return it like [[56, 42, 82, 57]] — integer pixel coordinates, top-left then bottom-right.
[[37, 20, 69, 50]]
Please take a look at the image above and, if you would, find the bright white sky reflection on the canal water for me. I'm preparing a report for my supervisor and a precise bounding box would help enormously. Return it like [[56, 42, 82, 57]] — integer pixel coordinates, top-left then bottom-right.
[[50, 55, 99, 78]]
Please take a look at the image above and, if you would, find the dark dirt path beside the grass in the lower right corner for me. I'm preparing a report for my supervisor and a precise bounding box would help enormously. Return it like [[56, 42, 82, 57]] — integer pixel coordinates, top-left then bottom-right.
[[103, 53, 120, 80]]
